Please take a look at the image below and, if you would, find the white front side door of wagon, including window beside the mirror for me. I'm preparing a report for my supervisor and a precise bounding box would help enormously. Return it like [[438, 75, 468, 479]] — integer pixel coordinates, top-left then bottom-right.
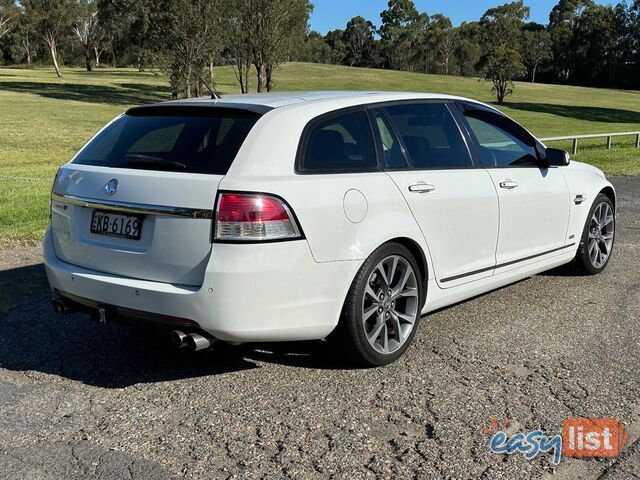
[[461, 104, 570, 273]]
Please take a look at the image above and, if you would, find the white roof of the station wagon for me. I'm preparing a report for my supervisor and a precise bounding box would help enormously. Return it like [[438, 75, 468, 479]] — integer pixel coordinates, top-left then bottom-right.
[[145, 91, 482, 113]]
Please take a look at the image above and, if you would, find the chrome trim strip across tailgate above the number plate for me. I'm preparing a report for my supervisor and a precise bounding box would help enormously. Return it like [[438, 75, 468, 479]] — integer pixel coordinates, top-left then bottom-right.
[[51, 193, 213, 220]]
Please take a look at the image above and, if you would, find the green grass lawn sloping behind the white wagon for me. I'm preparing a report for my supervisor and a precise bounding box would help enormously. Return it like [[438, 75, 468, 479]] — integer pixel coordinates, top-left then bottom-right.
[[0, 63, 640, 248]]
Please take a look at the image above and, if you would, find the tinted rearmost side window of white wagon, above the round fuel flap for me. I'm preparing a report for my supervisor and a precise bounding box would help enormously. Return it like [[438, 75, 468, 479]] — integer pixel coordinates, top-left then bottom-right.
[[301, 110, 378, 173]]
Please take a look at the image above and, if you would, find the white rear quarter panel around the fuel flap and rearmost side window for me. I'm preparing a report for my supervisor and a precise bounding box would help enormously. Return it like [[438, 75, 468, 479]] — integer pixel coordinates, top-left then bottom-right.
[[220, 101, 433, 281]]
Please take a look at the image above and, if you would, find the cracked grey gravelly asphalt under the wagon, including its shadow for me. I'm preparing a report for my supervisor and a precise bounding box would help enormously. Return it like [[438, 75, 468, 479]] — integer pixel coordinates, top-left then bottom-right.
[[0, 177, 640, 479]]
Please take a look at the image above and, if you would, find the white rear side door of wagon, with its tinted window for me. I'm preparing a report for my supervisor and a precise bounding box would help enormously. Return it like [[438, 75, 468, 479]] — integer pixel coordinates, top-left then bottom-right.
[[371, 101, 498, 288]]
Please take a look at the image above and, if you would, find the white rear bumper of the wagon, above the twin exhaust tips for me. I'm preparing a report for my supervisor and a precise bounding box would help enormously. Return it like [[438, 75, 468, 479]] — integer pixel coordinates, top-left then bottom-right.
[[44, 231, 361, 342]]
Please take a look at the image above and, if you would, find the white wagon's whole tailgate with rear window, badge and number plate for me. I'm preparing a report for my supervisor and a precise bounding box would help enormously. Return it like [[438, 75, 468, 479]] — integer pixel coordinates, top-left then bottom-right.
[[51, 106, 260, 286]]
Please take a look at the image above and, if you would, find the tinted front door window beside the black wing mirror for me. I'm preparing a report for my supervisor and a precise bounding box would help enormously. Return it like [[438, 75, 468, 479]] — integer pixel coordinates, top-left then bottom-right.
[[465, 110, 538, 168]]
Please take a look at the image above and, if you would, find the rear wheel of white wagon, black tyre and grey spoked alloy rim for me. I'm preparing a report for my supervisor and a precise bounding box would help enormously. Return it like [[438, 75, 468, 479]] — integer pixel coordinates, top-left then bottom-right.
[[335, 243, 425, 366]]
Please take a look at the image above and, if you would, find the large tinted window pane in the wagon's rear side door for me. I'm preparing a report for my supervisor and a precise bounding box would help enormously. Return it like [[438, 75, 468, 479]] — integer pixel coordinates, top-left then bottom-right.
[[387, 103, 472, 168]]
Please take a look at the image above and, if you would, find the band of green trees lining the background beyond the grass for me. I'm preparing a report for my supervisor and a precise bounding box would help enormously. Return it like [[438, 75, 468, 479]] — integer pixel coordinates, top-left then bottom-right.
[[0, 0, 640, 96]]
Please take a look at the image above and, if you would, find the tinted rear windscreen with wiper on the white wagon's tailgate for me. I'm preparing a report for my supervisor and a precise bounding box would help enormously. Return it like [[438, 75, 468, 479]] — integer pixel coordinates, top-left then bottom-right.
[[73, 107, 260, 175]]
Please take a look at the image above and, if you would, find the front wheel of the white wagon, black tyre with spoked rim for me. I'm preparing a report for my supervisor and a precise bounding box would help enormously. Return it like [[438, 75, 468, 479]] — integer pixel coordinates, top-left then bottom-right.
[[574, 194, 616, 275]]
